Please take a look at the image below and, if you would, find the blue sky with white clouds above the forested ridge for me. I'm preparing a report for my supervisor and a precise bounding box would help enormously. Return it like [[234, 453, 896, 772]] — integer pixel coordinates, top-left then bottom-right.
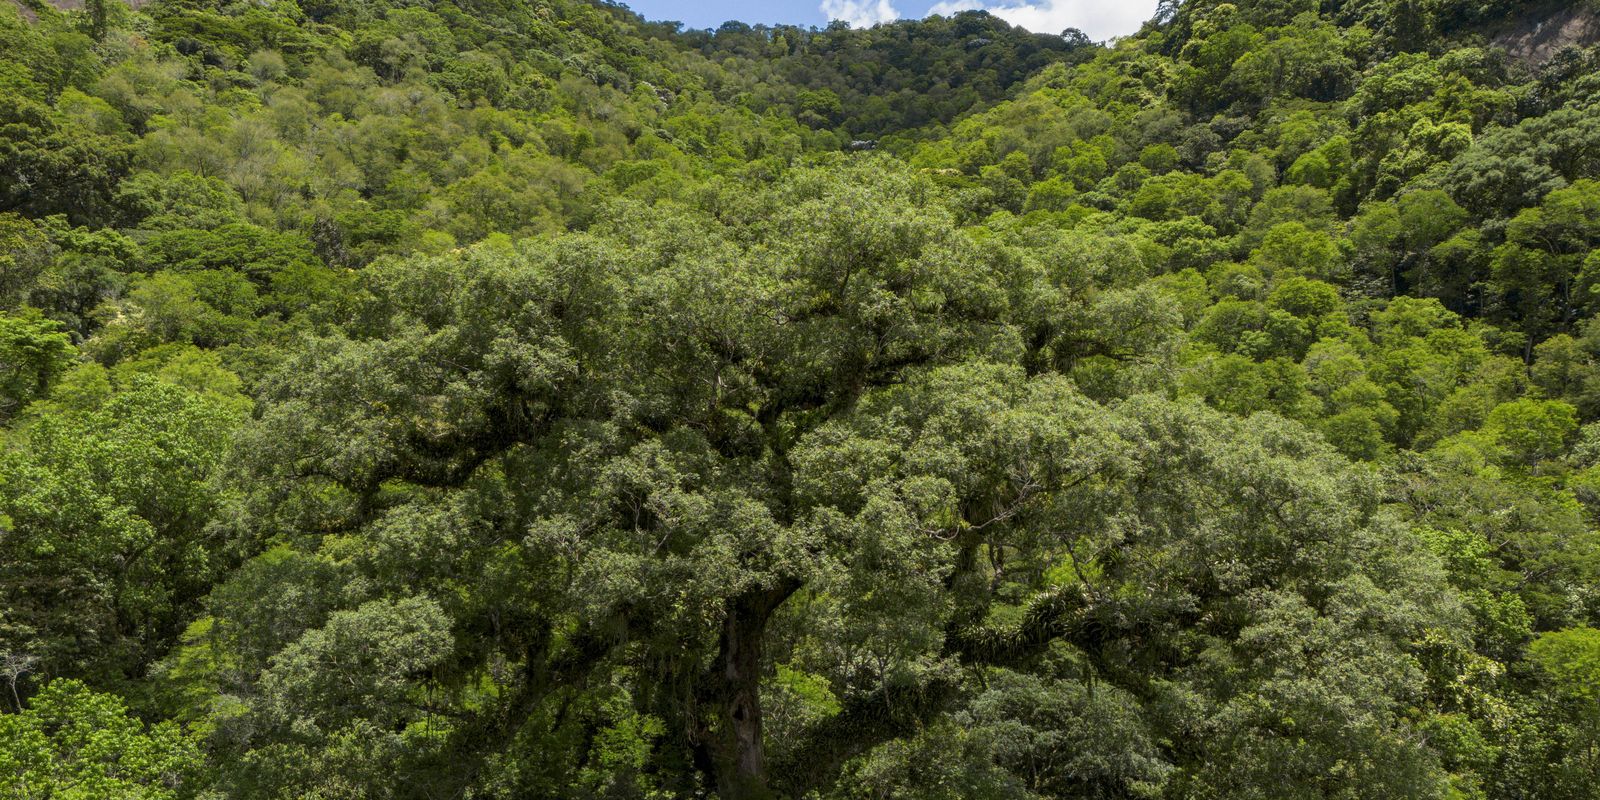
[[622, 0, 1155, 40]]
